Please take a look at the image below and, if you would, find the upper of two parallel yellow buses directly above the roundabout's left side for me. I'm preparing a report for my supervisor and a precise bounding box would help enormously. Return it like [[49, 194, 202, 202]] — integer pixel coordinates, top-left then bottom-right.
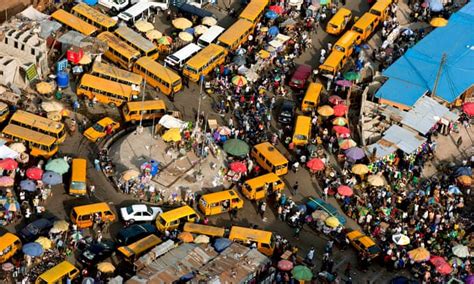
[[91, 61, 143, 95]]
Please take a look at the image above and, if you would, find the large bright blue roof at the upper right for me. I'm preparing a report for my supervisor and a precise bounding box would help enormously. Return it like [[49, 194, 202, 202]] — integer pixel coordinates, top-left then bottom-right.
[[375, 2, 474, 107]]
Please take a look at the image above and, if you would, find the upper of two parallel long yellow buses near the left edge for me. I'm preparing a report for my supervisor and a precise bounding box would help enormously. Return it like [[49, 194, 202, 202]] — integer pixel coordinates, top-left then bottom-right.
[[9, 110, 66, 144]]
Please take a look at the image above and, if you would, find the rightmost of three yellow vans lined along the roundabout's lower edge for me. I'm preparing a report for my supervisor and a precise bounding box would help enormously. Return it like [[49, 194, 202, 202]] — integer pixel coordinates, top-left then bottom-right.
[[242, 173, 285, 200]]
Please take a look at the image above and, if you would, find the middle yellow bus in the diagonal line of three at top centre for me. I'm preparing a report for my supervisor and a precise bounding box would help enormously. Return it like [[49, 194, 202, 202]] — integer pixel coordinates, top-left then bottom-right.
[[217, 19, 253, 51]]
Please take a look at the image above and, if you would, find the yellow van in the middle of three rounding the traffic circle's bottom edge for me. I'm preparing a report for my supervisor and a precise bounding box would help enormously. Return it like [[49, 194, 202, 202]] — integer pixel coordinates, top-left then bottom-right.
[[199, 189, 244, 216]]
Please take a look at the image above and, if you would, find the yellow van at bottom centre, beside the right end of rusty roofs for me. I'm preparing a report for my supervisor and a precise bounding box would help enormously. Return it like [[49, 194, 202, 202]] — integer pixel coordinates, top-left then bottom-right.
[[229, 226, 275, 256]]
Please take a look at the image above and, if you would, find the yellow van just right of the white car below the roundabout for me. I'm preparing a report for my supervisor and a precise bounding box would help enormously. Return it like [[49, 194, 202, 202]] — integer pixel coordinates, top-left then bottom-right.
[[156, 205, 199, 232]]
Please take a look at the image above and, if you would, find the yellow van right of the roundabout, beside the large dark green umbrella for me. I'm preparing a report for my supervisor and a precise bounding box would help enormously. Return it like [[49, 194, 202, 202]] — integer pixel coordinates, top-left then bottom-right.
[[251, 142, 288, 176]]
